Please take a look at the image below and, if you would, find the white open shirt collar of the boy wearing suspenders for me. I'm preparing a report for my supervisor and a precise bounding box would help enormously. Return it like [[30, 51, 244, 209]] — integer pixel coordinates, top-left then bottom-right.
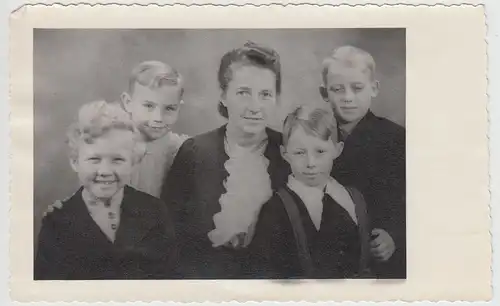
[[287, 175, 357, 230]]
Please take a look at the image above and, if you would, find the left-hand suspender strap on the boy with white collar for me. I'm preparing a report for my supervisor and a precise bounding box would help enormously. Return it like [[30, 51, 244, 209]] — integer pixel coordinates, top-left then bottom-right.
[[277, 188, 313, 277]]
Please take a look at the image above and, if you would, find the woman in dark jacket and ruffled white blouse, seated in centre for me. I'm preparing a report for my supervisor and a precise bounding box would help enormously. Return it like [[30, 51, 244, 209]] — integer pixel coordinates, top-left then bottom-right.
[[162, 42, 289, 279]]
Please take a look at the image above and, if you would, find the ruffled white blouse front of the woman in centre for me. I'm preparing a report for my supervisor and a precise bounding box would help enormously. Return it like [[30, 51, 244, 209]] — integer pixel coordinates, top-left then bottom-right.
[[208, 133, 272, 247]]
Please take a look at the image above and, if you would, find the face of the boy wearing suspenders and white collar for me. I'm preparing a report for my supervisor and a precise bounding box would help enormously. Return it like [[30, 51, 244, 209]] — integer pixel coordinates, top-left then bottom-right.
[[283, 126, 343, 188]]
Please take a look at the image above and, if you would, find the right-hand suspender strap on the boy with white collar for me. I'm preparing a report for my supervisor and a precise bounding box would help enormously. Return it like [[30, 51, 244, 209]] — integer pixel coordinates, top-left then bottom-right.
[[346, 187, 371, 277]]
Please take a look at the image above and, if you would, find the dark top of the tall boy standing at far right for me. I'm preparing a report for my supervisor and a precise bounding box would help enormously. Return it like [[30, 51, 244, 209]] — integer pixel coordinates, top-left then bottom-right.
[[332, 112, 406, 278]]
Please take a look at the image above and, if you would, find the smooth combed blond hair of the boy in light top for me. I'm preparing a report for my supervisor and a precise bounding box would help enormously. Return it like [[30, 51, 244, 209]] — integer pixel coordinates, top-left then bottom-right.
[[128, 61, 184, 95]]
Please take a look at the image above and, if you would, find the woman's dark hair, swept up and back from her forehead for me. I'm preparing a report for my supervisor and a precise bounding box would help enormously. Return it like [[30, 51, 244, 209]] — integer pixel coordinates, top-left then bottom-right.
[[217, 41, 281, 119]]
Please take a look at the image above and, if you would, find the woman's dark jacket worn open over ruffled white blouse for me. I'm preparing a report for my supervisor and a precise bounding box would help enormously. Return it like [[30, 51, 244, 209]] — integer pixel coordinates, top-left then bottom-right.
[[161, 126, 289, 279]]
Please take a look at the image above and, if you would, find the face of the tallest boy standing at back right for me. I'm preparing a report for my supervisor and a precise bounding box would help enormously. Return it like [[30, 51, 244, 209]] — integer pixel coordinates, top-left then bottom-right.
[[321, 62, 378, 124]]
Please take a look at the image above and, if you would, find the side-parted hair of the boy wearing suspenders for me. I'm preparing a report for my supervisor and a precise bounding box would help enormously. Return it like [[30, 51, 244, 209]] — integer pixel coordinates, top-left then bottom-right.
[[283, 106, 338, 147]]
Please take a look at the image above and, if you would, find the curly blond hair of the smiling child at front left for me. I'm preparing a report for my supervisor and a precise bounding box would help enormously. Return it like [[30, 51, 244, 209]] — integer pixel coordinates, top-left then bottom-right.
[[67, 100, 146, 162]]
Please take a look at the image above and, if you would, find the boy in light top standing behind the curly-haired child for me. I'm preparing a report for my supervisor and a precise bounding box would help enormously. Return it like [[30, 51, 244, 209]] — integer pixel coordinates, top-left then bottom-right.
[[44, 61, 188, 215]]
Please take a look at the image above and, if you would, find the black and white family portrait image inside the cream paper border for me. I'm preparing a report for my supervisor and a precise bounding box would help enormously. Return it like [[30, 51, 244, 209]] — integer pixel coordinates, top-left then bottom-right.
[[33, 28, 407, 280]]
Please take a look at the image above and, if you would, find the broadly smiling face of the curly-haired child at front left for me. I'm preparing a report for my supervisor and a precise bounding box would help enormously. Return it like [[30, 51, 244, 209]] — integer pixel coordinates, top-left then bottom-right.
[[71, 129, 136, 200]]
